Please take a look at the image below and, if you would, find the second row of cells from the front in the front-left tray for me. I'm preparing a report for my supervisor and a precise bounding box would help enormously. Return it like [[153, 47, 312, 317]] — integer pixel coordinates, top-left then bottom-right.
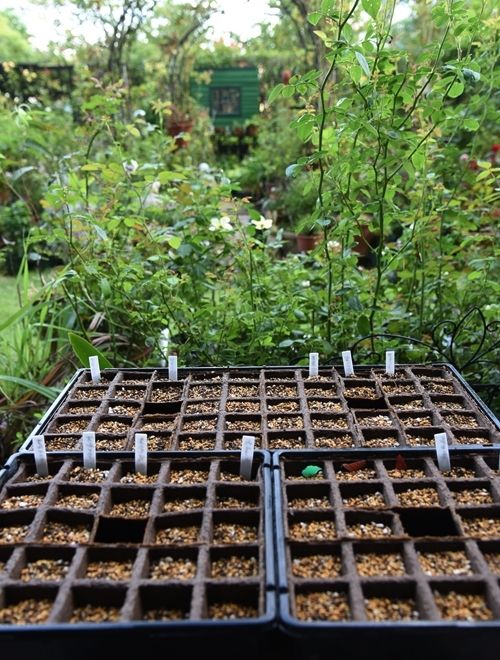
[[0, 545, 262, 584]]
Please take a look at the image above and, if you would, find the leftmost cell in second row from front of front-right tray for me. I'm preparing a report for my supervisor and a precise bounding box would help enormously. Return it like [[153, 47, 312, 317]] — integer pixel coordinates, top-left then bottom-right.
[[290, 543, 342, 580]]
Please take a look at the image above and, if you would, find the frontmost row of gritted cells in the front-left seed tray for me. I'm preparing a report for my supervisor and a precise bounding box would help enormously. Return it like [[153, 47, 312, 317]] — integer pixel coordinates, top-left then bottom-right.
[[0, 582, 265, 626]]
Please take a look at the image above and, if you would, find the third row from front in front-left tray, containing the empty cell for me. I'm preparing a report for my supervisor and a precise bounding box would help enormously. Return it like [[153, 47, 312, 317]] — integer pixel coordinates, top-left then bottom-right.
[[0, 508, 263, 545]]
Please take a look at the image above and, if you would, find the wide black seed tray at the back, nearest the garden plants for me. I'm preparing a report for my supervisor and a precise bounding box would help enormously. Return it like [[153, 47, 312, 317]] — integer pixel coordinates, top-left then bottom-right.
[[21, 364, 500, 452]]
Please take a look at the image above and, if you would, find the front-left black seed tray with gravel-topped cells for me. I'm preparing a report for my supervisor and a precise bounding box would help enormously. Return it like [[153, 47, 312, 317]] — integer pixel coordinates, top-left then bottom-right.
[[0, 451, 275, 657]]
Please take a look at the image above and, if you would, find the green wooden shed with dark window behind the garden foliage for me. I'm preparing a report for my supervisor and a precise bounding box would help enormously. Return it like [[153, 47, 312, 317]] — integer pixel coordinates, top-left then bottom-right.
[[191, 67, 260, 127]]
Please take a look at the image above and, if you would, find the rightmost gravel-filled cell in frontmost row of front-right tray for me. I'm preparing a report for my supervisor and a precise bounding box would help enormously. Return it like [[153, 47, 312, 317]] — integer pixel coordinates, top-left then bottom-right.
[[431, 582, 495, 621]]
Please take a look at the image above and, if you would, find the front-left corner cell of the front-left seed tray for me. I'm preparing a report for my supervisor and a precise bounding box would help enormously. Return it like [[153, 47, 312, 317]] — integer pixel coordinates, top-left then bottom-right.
[[0, 586, 57, 626]]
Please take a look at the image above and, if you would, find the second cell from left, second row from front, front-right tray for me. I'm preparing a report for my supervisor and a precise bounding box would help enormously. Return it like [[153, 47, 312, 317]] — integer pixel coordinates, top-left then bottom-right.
[[353, 542, 406, 578]]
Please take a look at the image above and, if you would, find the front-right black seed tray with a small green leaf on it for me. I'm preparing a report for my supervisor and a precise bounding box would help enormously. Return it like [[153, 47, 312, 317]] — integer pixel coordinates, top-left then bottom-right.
[[273, 450, 500, 660]]
